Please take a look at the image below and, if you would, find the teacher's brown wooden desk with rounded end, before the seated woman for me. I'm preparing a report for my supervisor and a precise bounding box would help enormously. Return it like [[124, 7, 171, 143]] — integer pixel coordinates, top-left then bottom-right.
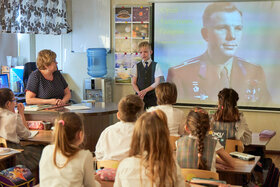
[[24, 102, 118, 151]]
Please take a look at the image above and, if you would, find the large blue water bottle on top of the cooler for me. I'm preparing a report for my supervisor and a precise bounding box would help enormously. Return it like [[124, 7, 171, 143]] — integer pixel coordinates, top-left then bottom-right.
[[87, 48, 107, 77]]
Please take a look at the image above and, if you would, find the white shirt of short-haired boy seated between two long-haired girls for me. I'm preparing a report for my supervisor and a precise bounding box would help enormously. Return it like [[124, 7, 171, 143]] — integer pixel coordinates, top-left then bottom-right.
[[95, 121, 134, 160]]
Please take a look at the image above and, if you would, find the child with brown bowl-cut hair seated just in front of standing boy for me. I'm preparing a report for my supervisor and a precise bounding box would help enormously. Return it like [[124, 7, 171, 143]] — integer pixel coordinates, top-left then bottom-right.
[[147, 82, 186, 136]]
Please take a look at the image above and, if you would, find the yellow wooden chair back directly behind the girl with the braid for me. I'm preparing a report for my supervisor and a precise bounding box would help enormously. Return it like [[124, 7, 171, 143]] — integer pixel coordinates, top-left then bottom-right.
[[181, 168, 219, 181]]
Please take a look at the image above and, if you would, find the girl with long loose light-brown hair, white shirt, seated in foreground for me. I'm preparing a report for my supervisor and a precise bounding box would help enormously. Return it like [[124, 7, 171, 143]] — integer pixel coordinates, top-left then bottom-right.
[[114, 110, 185, 187]]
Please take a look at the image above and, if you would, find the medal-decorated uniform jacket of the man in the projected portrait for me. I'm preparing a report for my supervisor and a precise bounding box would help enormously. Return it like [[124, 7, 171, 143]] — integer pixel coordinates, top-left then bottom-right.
[[167, 52, 271, 105]]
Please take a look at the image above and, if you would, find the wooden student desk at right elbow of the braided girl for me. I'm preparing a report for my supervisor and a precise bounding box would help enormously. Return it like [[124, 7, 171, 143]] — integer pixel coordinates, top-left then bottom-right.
[[217, 156, 260, 185]]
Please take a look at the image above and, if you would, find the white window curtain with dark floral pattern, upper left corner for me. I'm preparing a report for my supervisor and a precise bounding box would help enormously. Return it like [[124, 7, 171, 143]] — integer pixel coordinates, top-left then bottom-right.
[[0, 0, 71, 34]]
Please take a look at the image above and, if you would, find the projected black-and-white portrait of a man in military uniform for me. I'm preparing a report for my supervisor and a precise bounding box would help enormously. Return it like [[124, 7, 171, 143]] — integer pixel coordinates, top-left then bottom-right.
[[167, 2, 271, 104]]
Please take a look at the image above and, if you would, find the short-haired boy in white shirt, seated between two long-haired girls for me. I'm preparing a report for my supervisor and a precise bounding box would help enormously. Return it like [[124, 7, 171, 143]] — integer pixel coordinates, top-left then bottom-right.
[[95, 95, 144, 160]]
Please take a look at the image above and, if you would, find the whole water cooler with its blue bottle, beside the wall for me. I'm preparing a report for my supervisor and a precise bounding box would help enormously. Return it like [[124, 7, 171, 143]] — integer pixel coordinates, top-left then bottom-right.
[[84, 48, 113, 102]]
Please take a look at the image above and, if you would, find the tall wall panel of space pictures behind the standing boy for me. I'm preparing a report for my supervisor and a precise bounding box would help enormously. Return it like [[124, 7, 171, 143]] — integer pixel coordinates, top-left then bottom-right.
[[114, 6, 151, 83]]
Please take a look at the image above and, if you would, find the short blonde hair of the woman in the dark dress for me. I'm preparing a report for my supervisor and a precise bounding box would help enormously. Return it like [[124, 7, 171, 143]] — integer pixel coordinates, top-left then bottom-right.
[[36, 49, 56, 70]]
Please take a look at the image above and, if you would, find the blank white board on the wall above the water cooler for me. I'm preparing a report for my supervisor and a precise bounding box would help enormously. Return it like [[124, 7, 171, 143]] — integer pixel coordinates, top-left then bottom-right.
[[71, 0, 110, 52]]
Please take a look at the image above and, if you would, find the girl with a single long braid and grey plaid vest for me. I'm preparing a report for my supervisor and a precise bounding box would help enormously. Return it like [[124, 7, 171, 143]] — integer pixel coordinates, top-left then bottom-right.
[[176, 108, 234, 171]]
